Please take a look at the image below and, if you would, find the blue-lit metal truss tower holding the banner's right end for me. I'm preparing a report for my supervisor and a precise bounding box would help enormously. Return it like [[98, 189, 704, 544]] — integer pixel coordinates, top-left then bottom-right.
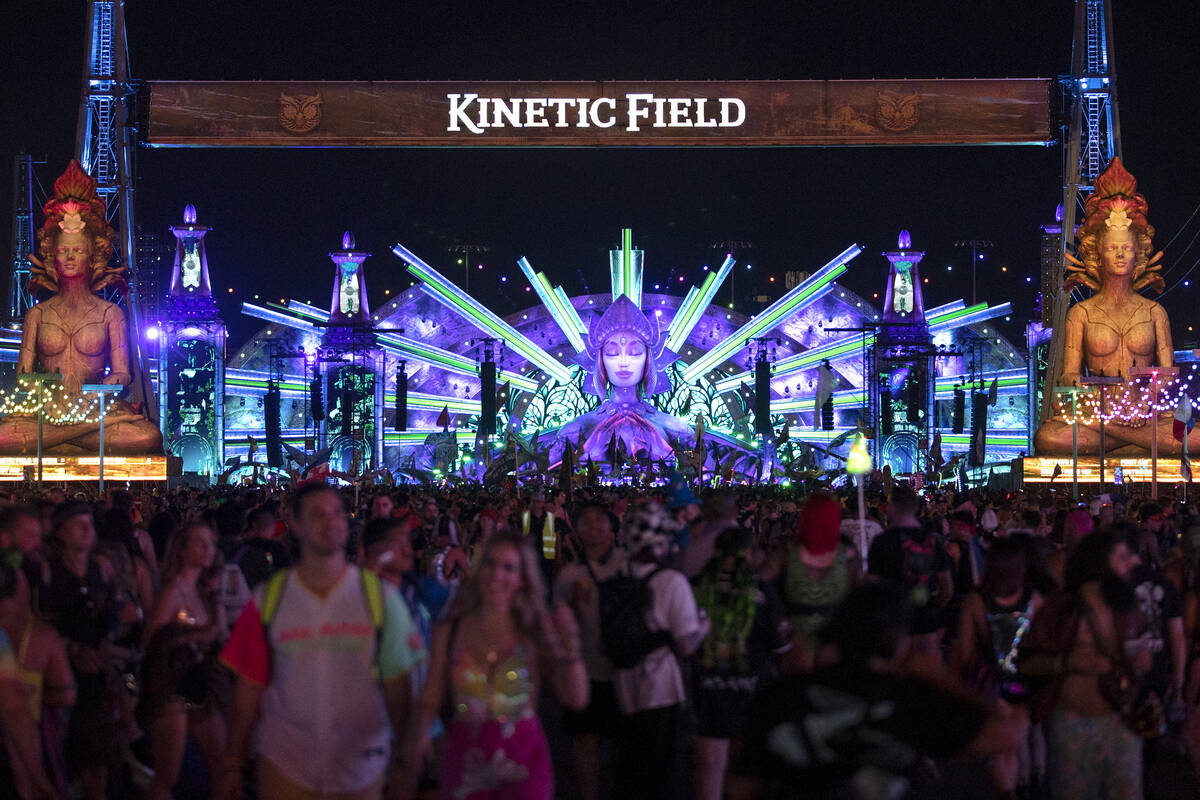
[[1042, 0, 1121, 420]]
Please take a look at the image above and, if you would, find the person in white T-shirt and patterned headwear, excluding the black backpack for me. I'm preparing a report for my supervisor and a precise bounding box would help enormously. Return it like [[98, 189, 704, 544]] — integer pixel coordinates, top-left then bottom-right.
[[613, 501, 709, 800]]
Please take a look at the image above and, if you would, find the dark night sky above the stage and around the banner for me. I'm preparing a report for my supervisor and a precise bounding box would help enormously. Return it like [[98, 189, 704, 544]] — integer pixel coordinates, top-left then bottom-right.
[[0, 0, 1200, 345]]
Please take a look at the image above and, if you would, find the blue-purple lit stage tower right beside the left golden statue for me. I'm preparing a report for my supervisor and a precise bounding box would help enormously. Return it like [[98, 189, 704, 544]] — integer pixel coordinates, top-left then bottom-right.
[[157, 205, 226, 475]]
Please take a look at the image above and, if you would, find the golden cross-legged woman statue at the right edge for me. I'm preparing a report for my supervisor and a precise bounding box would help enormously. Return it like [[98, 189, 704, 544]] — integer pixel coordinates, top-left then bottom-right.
[[1033, 158, 1200, 456]]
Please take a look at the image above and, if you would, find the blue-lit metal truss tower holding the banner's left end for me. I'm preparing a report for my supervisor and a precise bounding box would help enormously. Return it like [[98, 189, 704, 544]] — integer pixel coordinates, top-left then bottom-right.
[[76, 0, 157, 419]]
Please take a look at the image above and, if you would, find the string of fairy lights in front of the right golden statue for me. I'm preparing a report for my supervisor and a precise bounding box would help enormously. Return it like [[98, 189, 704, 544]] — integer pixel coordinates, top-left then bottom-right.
[[1055, 363, 1200, 426]]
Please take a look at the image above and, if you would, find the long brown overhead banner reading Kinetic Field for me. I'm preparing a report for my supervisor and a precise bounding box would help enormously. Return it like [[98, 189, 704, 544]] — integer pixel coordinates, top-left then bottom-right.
[[148, 78, 1054, 148]]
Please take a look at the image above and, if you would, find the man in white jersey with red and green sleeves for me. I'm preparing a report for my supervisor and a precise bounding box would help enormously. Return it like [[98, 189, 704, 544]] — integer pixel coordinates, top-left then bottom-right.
[[220, 483, 426, 800]]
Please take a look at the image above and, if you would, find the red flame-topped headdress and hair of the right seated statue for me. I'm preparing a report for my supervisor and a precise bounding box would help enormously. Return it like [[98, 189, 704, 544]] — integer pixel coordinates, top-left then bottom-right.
[[1066, 158, 1164, 291]]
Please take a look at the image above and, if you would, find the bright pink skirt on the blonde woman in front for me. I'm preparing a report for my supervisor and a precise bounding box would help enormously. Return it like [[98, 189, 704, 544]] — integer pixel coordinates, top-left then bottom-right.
[[438, 717, 554, 800]]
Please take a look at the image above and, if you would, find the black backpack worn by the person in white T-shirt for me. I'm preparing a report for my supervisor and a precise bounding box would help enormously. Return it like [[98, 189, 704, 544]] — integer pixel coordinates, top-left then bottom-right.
[[588, 564, 672, 669]]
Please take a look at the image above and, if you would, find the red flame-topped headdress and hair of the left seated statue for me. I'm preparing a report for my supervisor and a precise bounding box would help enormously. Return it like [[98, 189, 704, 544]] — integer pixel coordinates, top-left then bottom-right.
[[29, 160, 126, 291]]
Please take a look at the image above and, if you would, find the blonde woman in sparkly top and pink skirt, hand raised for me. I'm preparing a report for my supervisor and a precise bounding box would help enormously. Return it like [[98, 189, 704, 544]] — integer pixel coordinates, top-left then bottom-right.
[[406, 531, 588, 800]]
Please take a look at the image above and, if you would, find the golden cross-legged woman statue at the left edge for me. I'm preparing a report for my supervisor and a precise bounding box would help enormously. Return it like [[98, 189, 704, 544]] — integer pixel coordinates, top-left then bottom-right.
[[0, 161, 162, 455]]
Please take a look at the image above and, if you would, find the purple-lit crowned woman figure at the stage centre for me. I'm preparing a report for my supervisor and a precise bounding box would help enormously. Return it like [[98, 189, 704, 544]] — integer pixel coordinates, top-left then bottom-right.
[[551, 295, 695, 463]]
